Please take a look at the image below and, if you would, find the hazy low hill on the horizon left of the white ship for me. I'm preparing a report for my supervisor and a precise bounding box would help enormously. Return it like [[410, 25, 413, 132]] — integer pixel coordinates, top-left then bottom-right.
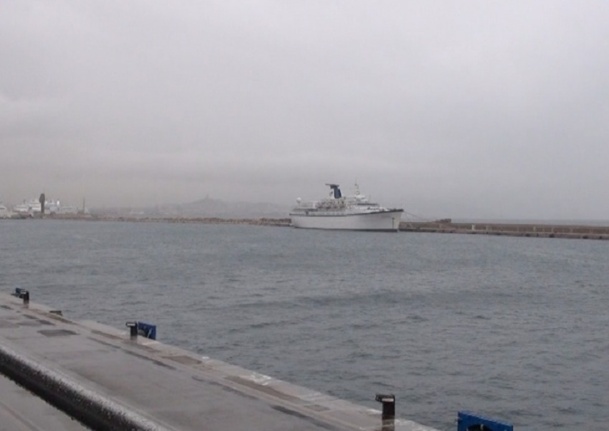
[[92, 198, 290, 218]]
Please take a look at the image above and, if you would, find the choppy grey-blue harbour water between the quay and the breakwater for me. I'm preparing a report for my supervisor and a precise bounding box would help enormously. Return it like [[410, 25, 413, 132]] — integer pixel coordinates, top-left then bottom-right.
[[0, 220, 609, 431]]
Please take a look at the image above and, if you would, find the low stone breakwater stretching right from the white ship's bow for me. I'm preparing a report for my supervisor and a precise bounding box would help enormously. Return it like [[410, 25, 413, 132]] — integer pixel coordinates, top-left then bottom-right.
[[400, 221, 609, 240]]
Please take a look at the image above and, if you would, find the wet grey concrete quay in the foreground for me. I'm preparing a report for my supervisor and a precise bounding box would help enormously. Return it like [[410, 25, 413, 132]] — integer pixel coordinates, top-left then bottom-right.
[[0, 293, 434, 431]]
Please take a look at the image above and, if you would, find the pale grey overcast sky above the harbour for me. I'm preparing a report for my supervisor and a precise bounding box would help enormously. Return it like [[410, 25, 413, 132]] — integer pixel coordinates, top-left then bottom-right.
[[0, 0, 609, 219]]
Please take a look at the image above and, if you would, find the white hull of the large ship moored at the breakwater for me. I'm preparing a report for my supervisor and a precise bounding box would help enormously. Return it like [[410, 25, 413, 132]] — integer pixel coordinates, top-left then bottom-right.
[[291, 209, 403, 232]]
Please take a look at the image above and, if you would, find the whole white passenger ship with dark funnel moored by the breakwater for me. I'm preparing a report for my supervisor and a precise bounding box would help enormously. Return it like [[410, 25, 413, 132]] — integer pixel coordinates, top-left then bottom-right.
[[290, 184, 404, 232]]
